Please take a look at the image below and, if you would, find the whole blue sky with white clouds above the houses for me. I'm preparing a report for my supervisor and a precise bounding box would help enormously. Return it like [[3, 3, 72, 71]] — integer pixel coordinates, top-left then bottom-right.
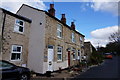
[[0, 0, 119, 47]]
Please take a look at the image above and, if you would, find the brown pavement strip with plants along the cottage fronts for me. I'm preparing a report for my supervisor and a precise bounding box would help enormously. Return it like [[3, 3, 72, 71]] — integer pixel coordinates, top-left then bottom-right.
[[31, 65, 97, 80]]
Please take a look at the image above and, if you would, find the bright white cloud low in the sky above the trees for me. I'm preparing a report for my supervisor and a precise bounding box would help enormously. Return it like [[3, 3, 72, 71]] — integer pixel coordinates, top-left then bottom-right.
[[85, 26, 118, 47]]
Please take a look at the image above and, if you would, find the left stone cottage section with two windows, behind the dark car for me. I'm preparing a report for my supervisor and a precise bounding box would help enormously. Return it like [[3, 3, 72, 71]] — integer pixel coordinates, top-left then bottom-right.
[[0, 8, 31, 67]]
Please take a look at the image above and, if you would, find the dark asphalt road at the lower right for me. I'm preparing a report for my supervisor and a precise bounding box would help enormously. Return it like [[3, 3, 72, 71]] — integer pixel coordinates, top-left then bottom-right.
[[73, 56, 120, 80]]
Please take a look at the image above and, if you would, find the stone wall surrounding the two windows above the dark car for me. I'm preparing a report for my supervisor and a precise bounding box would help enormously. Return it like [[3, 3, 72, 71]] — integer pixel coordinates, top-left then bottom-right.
[[2, 14, 30, 66]]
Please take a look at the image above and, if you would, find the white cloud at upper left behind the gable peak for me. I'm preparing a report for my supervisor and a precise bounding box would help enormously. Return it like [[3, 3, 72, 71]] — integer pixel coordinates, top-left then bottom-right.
[[0, 0, 46, 13]]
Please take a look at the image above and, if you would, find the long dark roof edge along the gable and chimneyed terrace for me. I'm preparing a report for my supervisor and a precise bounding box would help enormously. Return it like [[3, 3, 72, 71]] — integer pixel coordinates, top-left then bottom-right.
[[17, 4, 85, 37]]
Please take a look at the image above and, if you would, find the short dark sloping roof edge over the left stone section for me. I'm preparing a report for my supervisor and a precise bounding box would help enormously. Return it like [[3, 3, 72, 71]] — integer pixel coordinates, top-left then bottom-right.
[[0, 8, 32, 23]]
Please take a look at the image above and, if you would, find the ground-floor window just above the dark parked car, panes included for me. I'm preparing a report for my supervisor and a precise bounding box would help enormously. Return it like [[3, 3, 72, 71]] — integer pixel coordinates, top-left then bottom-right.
[[11, 45, 22, 60]]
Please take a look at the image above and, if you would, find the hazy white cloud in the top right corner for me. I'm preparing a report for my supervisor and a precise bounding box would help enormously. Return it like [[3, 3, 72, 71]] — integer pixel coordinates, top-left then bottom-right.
[[81, 0, 120, 16]]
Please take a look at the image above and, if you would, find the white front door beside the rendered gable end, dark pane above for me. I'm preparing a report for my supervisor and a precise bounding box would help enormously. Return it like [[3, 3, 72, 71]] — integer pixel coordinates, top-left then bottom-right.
[[47, 45, 54, 71]]
